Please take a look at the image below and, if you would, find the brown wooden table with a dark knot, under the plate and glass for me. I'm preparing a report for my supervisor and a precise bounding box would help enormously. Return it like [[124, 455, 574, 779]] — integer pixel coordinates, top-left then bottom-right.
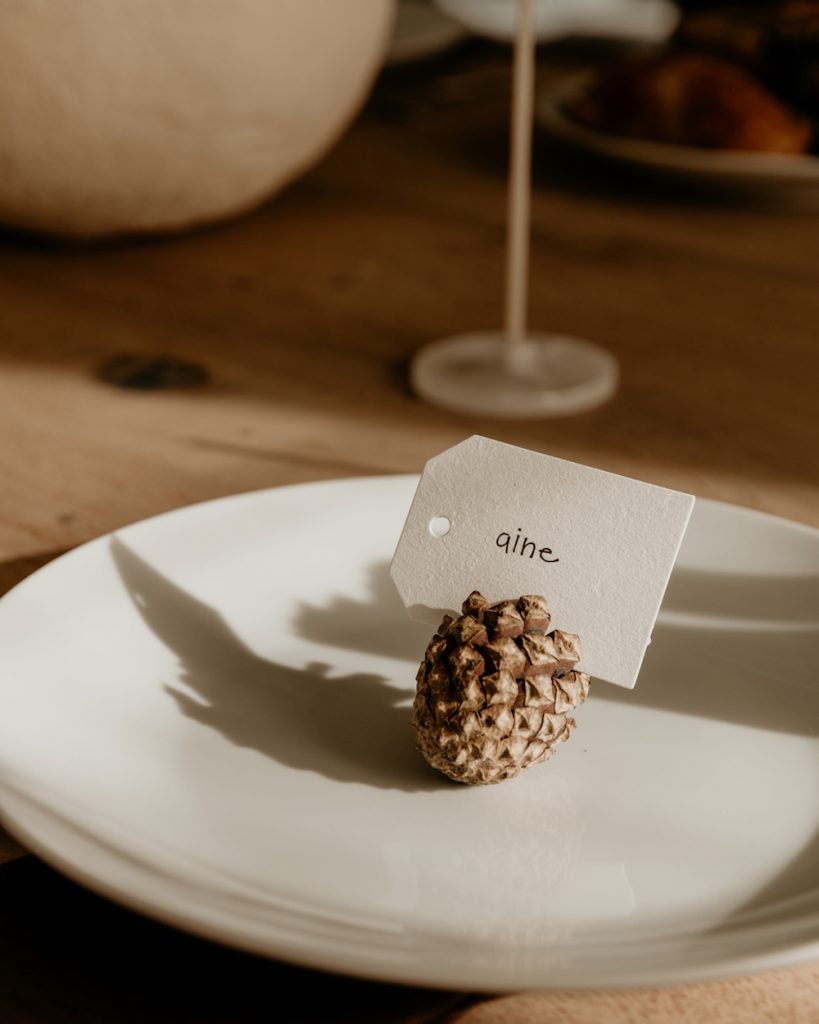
[[0, 44, 819, 1024]]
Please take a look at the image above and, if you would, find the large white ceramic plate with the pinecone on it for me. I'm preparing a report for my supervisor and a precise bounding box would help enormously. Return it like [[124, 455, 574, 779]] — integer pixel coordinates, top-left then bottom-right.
[[0, 477, 819, 990]]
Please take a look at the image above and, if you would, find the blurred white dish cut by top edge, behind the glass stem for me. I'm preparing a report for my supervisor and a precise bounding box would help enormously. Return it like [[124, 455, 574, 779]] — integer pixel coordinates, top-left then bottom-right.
[[435, 0, 679, 42]]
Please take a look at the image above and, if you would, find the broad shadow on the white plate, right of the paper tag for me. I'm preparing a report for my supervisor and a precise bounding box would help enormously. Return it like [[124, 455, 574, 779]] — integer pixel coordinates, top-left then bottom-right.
[[594, 567, 819, 740]]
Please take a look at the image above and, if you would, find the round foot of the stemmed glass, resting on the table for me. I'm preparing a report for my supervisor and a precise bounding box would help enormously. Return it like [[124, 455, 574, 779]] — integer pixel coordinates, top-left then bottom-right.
[[411, 332, 619, 420]]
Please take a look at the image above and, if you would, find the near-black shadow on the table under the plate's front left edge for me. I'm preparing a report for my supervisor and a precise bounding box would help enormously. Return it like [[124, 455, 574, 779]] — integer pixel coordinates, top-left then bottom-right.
[[0, 857, 469, 1024]]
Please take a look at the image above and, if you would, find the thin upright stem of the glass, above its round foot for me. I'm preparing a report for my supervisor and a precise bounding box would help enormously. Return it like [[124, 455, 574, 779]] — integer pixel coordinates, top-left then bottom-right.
[[505, 0, 534, 370]]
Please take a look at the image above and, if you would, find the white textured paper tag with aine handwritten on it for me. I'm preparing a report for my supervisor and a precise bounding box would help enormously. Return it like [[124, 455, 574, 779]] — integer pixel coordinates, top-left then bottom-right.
[[390, 436, 694, 689]]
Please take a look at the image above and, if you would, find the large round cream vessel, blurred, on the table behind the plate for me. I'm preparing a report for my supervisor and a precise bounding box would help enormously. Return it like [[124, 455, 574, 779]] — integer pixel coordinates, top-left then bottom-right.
[[0, 0, 395, 237]]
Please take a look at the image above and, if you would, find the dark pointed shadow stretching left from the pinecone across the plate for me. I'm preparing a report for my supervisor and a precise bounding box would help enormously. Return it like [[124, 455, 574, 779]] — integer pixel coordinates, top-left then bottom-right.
[[111, 537, 444, 792]]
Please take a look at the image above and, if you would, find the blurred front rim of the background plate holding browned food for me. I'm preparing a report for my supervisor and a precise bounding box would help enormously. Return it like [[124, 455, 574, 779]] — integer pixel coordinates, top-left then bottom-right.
[[535, 75, 819, 189]]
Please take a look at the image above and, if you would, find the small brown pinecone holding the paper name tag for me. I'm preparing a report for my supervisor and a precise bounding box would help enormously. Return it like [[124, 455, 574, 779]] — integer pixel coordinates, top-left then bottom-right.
[[413, 591, 589, 785]]
